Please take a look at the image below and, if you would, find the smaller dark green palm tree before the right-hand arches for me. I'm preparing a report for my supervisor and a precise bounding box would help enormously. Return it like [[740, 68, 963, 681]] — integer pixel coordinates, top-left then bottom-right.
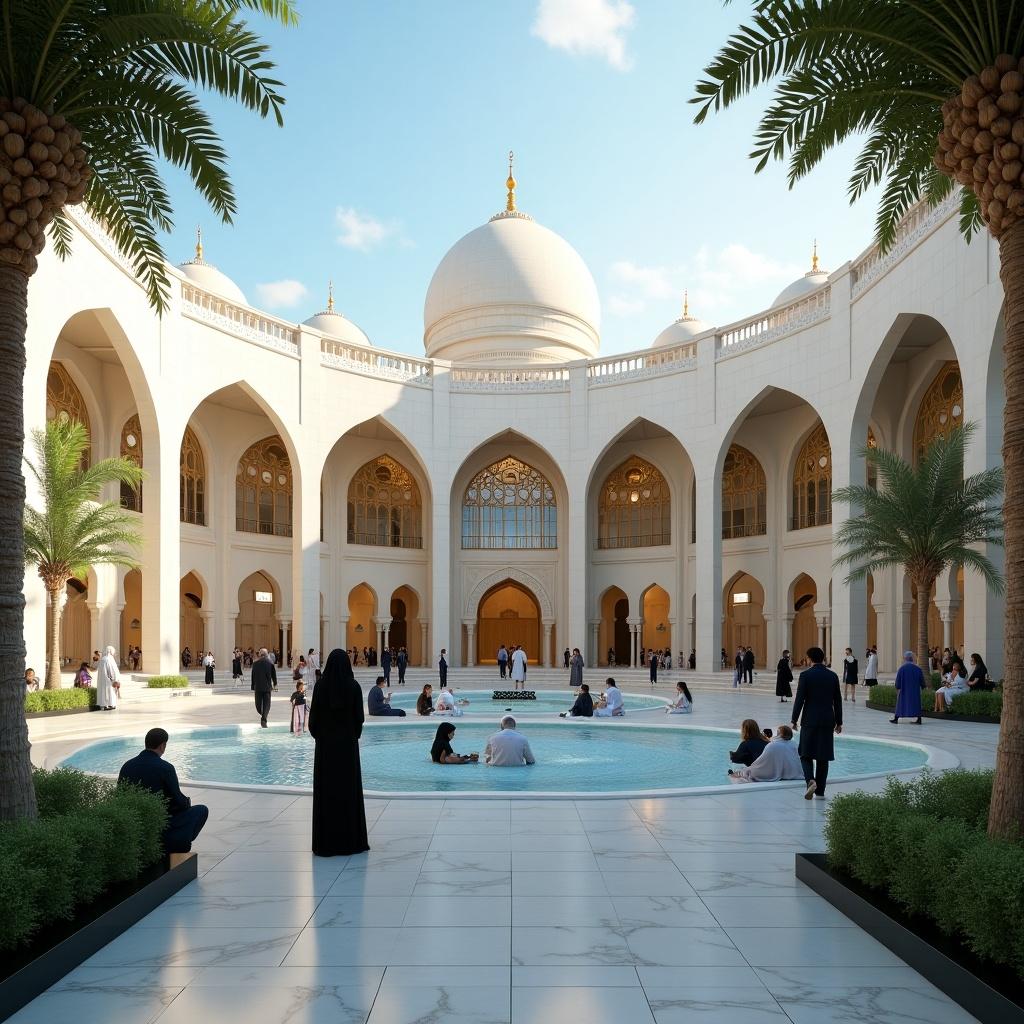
[[833, 423, 1004, 666]]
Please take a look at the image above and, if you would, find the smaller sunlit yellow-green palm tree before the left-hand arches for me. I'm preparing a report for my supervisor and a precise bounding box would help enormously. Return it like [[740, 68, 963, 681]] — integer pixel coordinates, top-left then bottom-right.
[[25, 420, 142, 690]]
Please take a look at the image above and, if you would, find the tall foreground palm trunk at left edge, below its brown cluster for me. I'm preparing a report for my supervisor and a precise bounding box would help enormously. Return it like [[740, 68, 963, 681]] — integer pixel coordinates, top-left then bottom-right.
[[0, 263, 36, 820]]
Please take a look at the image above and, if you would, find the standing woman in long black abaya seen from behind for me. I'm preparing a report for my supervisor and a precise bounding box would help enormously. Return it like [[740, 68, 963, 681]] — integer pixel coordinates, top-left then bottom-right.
[[308, 650, 370, 857]]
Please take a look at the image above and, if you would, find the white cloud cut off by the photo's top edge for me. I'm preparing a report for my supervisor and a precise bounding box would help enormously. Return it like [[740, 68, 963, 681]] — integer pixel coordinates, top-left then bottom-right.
[[529, 0, 636, 71]]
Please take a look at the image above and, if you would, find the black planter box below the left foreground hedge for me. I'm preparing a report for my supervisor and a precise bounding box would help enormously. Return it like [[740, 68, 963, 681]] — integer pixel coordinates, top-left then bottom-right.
[[0, 854, 199, 1021]]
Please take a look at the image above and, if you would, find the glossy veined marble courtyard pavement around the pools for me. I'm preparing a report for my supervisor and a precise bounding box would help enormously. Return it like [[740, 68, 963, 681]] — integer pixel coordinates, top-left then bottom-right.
[[11, 676, 996, 1024]]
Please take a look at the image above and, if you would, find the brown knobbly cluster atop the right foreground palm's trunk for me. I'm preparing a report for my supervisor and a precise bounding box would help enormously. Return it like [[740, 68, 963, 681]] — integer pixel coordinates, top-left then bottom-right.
[[935, 53, 1024, 238]]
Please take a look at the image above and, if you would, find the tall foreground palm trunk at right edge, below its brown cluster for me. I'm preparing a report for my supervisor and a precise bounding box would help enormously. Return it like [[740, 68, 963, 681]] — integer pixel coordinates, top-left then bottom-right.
[[988, 220, 1024, 837]]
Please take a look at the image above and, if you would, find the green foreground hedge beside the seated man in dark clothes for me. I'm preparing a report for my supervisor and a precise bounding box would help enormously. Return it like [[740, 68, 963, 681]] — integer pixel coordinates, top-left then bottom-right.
[[0, 768, 167, 950]]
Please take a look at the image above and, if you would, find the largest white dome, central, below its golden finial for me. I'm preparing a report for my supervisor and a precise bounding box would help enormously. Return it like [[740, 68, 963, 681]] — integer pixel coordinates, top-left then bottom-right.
[[423, 209, 601, 362]]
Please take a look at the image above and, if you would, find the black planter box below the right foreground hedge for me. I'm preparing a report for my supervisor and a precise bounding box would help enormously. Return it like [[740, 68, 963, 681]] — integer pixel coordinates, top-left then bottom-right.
[[797, 853, 1024, 1024]]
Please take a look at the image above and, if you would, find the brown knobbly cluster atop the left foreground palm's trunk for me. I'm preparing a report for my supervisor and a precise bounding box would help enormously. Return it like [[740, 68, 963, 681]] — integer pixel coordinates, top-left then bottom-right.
[[0, 98, 89, 274]]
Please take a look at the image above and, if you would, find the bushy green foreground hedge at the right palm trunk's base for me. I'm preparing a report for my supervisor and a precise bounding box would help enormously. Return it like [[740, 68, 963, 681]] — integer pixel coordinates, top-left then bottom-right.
[[824, 769, 1024, 979]]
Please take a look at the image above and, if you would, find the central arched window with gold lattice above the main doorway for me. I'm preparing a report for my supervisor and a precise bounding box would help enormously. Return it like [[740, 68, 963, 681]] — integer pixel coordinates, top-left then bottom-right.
[[462, 456, 558, 549]]
